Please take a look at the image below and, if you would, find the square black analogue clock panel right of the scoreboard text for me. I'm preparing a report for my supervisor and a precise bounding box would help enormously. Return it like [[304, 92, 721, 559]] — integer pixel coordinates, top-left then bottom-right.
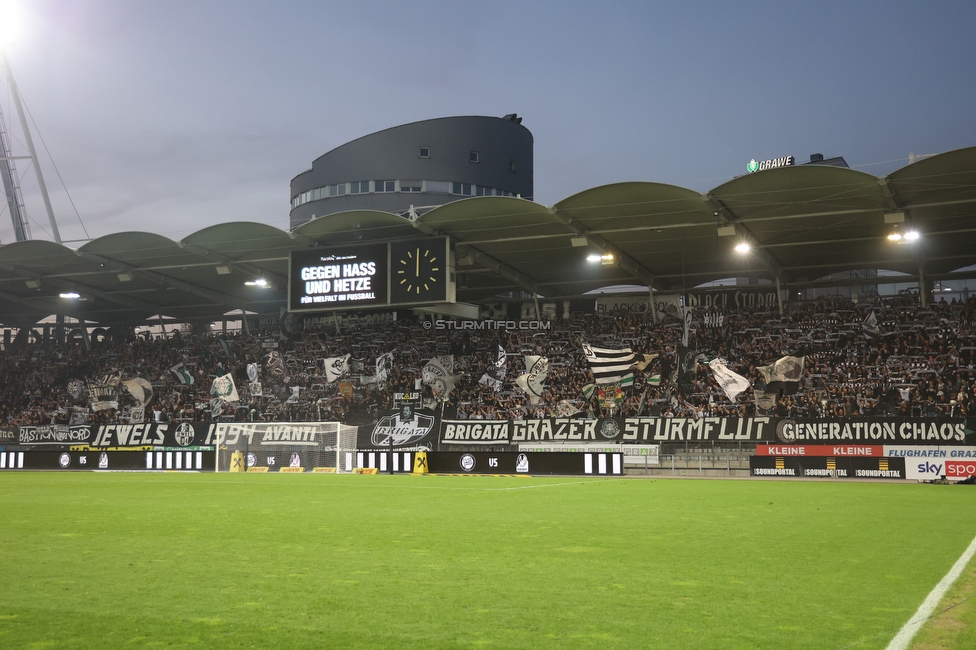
[[390, 239, 447, 303]]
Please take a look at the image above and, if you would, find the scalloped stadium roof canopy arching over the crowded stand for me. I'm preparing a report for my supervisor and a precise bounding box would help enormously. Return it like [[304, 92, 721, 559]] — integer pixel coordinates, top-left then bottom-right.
[[0, 147, 976, 327]]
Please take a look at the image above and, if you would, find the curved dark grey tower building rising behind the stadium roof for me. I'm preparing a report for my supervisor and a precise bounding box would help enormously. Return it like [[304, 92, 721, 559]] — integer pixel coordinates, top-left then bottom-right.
[[290, 113, 533, 228]]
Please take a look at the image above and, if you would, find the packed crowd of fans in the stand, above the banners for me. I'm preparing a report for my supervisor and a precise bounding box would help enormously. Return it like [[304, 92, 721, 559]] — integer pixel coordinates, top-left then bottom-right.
[[0, 290, 976, 425]]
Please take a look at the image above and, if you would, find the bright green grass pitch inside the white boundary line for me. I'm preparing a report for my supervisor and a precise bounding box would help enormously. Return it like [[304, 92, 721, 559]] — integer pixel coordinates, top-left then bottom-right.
[[0, 472, 976, 650]]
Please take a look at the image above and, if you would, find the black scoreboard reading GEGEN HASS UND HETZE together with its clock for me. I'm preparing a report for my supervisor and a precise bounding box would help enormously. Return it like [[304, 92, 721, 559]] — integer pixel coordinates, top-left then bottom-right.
[[288, 237, 454, 312]]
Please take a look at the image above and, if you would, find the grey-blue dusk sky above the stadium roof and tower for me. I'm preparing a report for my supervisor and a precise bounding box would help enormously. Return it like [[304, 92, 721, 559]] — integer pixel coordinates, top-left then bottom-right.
[[0, 0, 976, 245]]
